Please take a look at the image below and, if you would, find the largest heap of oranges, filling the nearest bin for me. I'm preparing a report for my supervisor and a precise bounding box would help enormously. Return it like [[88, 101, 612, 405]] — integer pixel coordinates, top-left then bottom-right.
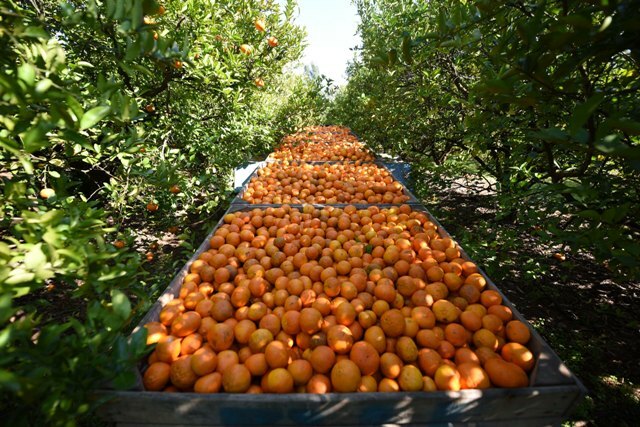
[[143, 205, 535, 393]]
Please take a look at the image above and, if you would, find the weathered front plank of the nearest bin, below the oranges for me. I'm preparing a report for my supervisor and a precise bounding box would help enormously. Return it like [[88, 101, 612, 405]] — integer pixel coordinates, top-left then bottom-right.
[[99, 386, 579, 426]]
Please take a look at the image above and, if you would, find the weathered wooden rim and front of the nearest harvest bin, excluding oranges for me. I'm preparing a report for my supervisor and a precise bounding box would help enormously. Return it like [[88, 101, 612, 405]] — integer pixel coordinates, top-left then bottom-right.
[[97, 205, 586, 426]]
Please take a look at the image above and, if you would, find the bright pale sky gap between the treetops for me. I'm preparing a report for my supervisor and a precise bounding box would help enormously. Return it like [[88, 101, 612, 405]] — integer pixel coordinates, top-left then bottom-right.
[[280, 0, 360, 85]]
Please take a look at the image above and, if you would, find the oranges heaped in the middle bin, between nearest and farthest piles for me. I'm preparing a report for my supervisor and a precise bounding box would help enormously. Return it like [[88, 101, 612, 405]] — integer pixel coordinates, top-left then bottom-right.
[[242, 161, 409, 204]]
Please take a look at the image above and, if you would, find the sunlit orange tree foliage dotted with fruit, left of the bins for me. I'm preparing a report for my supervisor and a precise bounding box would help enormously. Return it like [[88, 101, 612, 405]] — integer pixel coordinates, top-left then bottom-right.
[[0, 0, 322, 425]]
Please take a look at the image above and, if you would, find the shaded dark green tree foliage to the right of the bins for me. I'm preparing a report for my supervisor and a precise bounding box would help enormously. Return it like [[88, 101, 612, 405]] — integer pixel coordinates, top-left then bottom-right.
[[330, 0, 640, 277]]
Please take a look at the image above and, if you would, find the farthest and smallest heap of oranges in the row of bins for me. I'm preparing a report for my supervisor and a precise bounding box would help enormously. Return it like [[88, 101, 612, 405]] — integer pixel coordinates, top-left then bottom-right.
[[271, 126, 374, 161]]
